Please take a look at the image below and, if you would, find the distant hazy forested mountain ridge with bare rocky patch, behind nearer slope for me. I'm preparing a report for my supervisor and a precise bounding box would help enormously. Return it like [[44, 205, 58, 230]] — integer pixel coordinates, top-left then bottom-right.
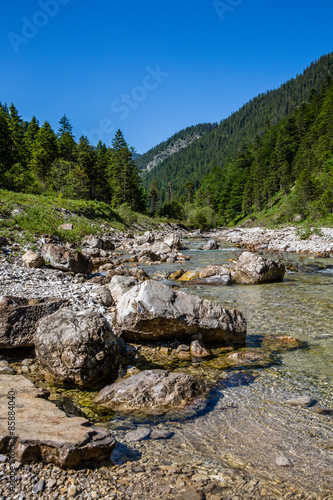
[[139, 53, 333, 203]]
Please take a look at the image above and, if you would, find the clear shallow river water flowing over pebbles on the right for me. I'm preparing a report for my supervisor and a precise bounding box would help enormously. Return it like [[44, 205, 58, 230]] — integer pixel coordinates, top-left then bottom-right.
[[133, 240, 333, 498]]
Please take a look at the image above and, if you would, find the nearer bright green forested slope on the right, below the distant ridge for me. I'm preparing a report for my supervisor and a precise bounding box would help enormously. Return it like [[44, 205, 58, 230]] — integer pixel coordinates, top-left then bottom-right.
[[195, 76, 333, 224]]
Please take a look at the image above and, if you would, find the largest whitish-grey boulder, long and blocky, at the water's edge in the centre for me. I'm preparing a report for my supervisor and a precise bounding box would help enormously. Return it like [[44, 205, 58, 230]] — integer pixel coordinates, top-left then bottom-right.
[[116, 280, 246, 346]]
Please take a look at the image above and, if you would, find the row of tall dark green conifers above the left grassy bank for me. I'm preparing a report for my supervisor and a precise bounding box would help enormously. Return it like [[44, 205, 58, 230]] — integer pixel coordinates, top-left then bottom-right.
[[0, 107, 147, 212]]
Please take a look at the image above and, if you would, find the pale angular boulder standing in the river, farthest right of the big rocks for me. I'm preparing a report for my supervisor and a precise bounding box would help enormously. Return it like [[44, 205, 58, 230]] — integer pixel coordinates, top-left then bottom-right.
[[231, 252, 285, 285]]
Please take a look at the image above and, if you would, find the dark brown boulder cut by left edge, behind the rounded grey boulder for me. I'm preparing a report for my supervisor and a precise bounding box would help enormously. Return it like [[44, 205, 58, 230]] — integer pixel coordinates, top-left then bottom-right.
[[0, 296, 68, 349]]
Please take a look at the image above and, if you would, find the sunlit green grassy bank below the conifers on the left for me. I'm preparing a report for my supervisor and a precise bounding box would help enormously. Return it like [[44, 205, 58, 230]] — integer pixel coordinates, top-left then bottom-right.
[[0, 190, 158, 245]]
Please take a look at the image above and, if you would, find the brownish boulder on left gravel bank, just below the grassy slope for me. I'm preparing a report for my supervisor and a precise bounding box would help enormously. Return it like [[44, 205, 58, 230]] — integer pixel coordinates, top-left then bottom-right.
[[42, 244, 93, 274]]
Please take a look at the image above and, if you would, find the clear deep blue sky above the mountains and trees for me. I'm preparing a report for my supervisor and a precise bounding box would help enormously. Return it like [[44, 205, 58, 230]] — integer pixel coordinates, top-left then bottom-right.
[[0, 0, 333, 153]]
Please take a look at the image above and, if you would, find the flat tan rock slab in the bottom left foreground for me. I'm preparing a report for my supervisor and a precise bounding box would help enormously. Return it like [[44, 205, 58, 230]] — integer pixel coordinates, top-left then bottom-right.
[[0, 375, 116, 468]]
